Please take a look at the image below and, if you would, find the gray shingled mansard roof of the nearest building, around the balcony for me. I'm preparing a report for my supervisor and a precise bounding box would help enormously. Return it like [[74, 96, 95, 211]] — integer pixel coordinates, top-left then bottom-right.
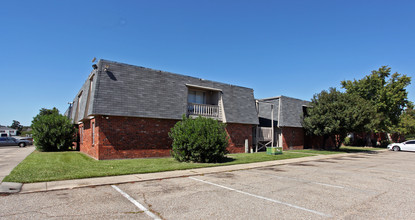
[[67, 60, 258, 124]]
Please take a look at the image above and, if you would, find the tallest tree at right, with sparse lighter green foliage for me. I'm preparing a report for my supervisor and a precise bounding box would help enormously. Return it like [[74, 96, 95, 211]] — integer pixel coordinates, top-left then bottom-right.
[[341, 66, 411, 132]]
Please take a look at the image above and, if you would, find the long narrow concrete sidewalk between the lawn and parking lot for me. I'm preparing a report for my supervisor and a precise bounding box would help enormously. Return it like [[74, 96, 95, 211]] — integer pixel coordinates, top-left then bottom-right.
[[20, 151, 382, 193]]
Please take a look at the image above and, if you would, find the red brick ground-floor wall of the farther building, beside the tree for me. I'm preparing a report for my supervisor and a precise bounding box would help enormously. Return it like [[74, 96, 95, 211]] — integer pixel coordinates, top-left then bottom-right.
[[281, 127, 304, 150]]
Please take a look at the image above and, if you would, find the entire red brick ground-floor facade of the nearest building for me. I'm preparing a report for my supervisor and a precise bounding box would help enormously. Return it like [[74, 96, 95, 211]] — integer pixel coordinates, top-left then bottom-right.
[[79, 116, 252, 160]]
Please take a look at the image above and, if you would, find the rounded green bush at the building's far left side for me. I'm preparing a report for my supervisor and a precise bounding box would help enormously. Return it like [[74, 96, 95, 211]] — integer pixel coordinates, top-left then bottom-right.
[[31, 108, 75, 151]]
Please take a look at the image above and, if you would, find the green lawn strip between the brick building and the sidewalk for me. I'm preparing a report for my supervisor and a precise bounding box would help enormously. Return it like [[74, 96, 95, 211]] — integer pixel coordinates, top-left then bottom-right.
[[3, 147, 383, 183]]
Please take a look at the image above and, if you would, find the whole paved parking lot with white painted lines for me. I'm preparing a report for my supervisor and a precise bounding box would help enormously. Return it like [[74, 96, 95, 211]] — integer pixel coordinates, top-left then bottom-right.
[[0, 152, 415, 219]]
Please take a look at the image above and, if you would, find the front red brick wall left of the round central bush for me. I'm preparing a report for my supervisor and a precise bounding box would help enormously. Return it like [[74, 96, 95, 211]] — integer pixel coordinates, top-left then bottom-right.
[[96, 116, 177, 160]]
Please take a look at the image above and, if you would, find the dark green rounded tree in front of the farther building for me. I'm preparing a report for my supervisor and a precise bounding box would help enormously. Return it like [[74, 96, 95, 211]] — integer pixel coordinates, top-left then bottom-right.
[[303, 88, 374, 149]]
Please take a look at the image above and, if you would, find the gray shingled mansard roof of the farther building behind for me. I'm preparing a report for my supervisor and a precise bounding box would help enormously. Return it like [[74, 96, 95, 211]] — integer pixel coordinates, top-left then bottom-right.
[[258, 96, 310, 127]]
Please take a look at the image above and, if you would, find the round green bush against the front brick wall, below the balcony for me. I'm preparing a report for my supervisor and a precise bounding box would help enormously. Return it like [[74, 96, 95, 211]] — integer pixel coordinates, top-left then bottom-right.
[[169, 116, 228, 163]]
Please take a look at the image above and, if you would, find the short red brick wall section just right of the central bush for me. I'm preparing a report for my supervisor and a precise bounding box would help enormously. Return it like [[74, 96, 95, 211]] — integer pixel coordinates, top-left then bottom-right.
[[226, 124, 253, 153]]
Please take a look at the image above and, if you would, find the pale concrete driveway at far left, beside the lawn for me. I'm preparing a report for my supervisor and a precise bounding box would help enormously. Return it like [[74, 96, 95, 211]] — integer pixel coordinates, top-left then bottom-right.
[[0, 145, 35, 182]]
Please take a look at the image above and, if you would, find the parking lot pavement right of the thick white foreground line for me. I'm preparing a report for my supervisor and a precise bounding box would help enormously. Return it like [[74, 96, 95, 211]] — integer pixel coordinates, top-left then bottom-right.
[[113, 152, 415, 219]]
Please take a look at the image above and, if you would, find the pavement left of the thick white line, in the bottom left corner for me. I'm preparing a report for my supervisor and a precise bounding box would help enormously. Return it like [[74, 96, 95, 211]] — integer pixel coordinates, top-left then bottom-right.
[[0, 186, 151, 219]]
